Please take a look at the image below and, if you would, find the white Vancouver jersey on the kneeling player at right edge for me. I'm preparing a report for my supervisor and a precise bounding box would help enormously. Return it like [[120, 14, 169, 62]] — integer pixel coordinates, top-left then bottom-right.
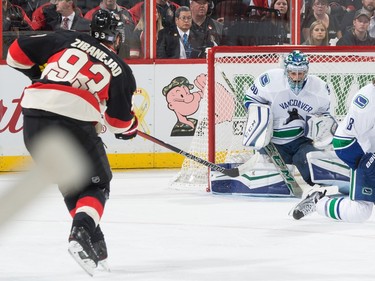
[[333, 83, 375, 169]]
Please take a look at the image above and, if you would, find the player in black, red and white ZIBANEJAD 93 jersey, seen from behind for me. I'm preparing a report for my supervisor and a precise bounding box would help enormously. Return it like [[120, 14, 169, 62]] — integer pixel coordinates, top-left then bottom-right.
[[7, 10, 138, 275]]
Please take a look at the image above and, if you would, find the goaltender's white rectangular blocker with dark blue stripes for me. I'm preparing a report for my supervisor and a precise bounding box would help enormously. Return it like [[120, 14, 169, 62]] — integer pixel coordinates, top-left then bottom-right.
[[242, 103, 273, 150]]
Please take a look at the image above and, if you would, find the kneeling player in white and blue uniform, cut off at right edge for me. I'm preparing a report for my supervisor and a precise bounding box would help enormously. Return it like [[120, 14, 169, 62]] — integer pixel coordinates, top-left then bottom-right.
[[293, 79, 375, 222]]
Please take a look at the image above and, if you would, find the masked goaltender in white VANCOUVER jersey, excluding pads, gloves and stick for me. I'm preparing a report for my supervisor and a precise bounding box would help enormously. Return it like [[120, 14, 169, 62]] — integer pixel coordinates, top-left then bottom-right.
[[244, 51, 330, 185]]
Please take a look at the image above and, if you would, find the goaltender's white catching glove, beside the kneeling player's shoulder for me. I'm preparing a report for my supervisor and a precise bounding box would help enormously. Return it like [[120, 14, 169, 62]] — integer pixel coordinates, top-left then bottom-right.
[[305, 113, 337, 148]]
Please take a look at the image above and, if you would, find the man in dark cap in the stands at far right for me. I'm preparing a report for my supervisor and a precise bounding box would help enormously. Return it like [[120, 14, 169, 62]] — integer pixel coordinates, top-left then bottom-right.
[[337, 9, 375, 46]]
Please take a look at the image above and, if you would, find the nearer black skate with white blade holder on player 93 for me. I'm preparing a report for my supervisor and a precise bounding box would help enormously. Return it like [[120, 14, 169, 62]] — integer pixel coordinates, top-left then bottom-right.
[[68, 226, 99, 276]]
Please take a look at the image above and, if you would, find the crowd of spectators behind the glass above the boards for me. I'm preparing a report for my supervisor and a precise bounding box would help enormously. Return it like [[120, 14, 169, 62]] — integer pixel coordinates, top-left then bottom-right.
[[2, 0, 375, 59]]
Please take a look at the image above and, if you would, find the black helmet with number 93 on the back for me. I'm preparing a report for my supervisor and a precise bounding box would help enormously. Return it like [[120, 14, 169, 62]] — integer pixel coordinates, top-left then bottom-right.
[[90, 10, 125, 43]]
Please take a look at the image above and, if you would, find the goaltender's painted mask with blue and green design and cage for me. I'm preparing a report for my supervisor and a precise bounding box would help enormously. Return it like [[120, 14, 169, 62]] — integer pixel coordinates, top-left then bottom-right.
[[284, 51, 309, 95]]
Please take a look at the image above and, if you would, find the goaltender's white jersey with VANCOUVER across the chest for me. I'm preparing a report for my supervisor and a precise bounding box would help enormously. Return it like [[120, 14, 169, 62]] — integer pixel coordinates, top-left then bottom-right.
[[244, 69, 330, 144]]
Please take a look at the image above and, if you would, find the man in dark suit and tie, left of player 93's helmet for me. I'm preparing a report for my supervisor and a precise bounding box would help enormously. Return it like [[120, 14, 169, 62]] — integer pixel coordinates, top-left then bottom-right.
[[54, 0, 90, 32]]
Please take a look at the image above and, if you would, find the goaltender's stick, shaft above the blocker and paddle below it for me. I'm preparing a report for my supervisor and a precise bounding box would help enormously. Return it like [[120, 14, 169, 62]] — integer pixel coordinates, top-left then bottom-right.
[[220, 70, 303, 198]]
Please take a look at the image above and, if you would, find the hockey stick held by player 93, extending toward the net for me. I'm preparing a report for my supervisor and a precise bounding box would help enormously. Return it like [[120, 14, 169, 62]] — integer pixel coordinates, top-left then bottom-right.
[[138, 131, 258, 177]]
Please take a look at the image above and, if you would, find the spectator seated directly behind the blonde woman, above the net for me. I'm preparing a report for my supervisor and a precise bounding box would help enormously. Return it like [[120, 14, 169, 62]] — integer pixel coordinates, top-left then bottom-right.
[[302, 0, 342, 41]]
